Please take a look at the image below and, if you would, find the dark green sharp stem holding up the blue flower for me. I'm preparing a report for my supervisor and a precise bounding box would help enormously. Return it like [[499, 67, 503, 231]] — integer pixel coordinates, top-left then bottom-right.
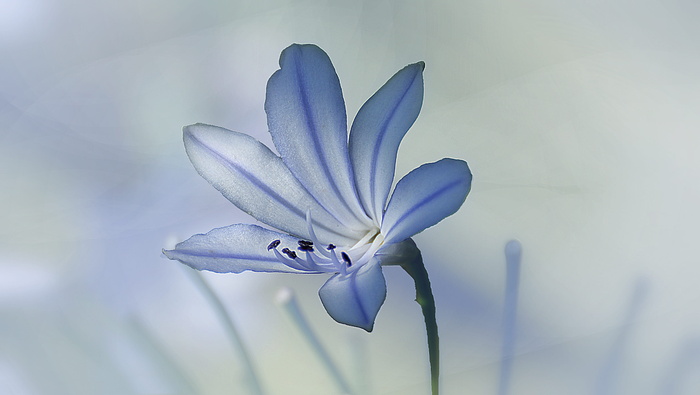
[[401, 249, 440, 395]]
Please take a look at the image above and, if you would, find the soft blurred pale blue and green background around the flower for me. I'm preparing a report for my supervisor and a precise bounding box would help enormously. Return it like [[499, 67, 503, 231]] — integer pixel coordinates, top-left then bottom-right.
[[0, 0, 700, 395]]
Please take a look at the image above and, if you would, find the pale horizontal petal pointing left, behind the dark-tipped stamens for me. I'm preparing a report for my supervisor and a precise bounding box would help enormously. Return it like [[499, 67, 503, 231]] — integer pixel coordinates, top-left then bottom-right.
[[163, 224, 318, 273]]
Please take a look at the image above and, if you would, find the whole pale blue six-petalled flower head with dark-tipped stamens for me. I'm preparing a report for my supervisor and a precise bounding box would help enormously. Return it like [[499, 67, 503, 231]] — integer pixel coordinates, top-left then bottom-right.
[[164, 44, 471, 332]]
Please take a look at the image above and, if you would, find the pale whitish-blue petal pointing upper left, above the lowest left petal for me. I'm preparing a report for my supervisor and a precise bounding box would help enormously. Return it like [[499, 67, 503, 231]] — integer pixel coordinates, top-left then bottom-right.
[[184, 124, 363, 248]]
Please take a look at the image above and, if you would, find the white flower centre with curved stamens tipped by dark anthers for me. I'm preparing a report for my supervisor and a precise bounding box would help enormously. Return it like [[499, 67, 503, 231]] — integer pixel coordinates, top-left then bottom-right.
[[267, 213, 384, 274]]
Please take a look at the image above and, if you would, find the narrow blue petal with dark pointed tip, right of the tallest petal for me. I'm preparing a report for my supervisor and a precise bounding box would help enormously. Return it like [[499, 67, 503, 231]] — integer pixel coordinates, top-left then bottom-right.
[[350, 62, 425, 221]]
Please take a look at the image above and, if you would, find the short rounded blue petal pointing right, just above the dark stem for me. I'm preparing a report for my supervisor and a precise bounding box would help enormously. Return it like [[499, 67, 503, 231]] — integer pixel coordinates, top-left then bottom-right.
[[382, 159, 472, 244]]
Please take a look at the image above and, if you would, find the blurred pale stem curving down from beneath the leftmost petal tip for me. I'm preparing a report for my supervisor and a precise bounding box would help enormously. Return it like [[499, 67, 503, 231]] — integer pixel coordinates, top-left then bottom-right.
[[186, 269, 263, 395]]
